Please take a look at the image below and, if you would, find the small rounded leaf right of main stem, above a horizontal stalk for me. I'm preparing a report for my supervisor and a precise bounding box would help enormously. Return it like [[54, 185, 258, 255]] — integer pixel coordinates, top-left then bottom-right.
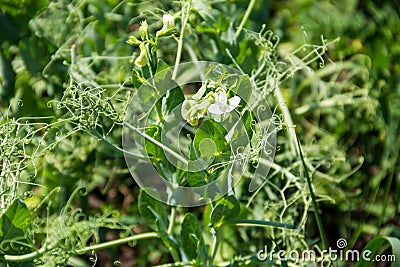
[[211, 196, 240, 228]]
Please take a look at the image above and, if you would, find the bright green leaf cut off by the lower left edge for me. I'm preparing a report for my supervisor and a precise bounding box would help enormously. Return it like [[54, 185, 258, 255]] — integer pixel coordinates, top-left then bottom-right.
[[0, 199, 33, 266]]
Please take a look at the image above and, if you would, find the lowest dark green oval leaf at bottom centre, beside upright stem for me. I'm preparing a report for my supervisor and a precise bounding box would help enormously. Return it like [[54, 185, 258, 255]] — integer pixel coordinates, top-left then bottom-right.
[[181, 213, 208, 263]]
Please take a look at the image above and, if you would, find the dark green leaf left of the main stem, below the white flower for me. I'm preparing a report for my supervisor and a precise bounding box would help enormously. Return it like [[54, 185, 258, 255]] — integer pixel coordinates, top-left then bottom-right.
[[138, 189, 168, 231]]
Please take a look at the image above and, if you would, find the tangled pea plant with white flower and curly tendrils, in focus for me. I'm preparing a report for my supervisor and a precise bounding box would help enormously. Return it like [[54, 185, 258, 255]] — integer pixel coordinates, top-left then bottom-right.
[[0, 0, 394, 266]]
